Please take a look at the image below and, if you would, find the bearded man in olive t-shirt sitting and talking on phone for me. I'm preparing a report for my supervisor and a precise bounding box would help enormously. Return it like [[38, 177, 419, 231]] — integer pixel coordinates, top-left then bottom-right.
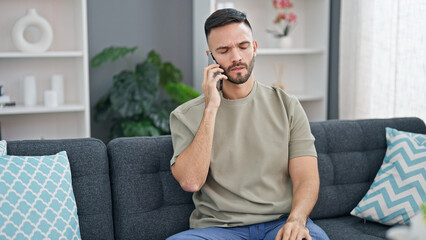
[[169, 9, 328, 240]]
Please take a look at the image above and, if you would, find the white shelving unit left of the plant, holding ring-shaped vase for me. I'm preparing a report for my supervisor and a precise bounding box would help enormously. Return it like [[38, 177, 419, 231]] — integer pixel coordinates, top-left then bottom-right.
[[0, 0, 90, 140]]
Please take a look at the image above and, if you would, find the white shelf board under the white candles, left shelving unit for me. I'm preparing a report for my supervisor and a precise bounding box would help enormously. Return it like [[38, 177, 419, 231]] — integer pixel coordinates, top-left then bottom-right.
[[0, 104, 84, 116]]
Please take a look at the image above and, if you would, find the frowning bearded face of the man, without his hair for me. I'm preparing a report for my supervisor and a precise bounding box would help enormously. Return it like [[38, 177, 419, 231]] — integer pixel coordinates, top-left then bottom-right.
[[208, 23, 257, 84]]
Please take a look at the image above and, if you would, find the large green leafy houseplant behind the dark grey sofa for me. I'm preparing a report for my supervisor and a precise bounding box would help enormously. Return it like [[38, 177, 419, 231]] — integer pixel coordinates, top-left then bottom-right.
[[90, 47, 200, 138]]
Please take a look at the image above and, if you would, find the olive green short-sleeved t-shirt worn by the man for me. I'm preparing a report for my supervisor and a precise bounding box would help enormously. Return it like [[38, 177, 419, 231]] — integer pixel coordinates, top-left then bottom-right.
[[170, 81, 316, 228]]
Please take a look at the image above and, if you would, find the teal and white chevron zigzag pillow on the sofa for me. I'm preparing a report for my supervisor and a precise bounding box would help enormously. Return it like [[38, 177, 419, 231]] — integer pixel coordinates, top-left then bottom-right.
[[351, 128, 426, 225]]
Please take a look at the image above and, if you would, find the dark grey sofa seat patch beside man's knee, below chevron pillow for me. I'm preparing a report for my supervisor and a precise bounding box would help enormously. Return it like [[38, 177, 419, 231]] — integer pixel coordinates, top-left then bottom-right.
[[314, 216, 389, 240]]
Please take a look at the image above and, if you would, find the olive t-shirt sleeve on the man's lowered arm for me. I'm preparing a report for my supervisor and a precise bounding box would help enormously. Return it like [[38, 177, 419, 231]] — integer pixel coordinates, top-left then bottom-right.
[[289, 97, 317, 159]]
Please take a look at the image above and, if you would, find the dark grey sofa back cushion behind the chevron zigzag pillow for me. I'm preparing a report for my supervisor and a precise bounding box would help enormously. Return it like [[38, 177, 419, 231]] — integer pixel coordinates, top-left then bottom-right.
[[311, 118, 426, 219]]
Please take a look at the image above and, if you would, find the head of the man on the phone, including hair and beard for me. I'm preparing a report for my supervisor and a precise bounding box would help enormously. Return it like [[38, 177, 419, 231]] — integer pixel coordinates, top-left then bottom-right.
[[204, 8, 257, 84]]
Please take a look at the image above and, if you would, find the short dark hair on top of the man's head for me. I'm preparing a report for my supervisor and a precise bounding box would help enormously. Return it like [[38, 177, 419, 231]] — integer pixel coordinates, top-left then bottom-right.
[[204, 8, 252, 39]]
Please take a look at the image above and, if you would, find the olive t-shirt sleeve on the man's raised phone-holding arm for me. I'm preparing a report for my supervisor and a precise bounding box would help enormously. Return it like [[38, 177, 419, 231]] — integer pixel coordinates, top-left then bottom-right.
[[170, 109, 194, 166]]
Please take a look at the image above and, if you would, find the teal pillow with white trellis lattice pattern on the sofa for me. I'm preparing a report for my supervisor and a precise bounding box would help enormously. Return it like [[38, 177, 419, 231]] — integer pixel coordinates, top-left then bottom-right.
[[0, 151, 81, 239]]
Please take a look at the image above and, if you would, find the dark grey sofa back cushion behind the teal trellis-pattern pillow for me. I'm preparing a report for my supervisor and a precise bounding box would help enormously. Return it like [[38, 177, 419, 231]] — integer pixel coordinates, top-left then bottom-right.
[[7, 138, 114, 239]]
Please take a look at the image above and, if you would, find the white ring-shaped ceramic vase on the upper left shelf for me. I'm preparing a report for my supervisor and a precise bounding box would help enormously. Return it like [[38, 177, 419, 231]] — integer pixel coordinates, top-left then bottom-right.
[[12, 8, 53, 53]]
